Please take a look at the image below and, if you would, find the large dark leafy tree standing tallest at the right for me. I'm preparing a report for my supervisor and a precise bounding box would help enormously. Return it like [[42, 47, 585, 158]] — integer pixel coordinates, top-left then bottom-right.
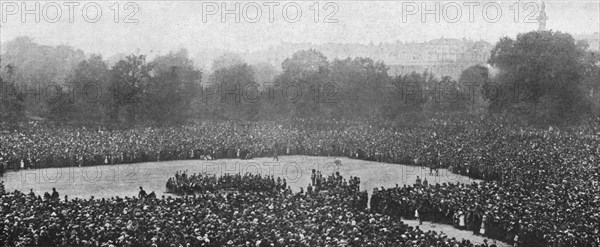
[[487, 31, 589, 123]]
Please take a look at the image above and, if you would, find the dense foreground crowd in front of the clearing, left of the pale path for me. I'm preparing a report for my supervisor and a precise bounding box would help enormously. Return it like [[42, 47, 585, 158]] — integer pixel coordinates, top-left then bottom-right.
[[0, 173, 504, 247]]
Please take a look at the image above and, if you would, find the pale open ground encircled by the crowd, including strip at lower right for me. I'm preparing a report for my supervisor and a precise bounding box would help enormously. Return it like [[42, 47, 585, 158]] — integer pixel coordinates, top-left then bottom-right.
[[2, 156, 509, 246]]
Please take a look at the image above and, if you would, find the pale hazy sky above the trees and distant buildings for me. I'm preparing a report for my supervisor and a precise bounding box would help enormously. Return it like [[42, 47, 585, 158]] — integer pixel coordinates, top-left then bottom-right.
[[0, 0, 600, 56]]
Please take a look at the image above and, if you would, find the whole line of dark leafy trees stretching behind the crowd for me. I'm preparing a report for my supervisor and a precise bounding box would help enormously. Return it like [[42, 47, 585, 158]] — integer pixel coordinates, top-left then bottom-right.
[[0, 31, 600, 126]]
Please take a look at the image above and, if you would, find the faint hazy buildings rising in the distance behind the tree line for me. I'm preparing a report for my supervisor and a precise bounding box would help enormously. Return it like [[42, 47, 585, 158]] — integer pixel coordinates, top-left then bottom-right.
[[234, 38, 493, 79]]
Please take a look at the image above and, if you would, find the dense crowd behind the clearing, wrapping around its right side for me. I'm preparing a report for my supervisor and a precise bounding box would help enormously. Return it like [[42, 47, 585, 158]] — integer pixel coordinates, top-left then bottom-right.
[[0, 117, 600, 246]]
